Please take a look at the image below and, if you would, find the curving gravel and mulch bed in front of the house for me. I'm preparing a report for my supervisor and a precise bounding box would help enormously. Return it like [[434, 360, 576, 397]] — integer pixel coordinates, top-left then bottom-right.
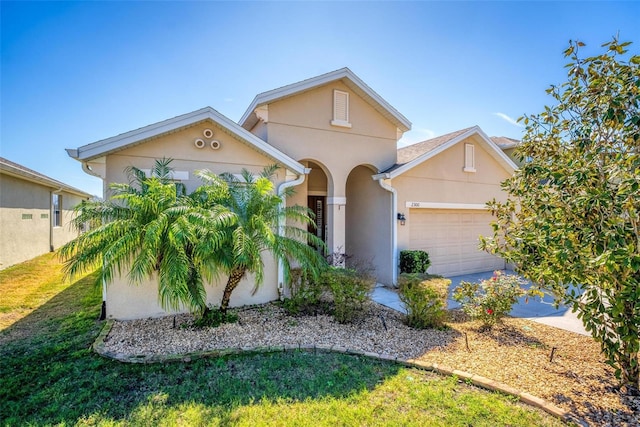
[[104, 302, 640, 426]]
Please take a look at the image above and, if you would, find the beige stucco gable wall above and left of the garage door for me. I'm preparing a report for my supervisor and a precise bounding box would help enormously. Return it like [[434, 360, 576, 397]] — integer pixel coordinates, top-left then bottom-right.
[[392, 137, 510, 250]]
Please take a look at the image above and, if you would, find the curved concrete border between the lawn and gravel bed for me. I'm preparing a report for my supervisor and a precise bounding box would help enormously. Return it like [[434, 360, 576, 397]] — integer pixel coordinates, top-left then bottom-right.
[[91, 320, 586, 426]]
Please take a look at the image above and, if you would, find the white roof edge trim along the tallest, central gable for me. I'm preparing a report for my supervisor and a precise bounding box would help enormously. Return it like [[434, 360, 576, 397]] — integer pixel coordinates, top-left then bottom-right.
[[239, 68, 411, 132]]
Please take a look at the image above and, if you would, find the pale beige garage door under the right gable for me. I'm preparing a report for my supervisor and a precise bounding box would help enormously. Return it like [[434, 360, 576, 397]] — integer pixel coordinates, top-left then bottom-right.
[[409, 209, 505, 276]]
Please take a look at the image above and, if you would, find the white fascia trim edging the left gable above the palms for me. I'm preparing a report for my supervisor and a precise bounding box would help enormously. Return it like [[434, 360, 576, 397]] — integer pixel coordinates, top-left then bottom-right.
[[67, 107, 308, 174]]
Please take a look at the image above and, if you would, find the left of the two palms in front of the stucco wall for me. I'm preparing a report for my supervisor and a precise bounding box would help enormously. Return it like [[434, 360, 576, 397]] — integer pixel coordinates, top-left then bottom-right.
[[59, 159, 206, 312]]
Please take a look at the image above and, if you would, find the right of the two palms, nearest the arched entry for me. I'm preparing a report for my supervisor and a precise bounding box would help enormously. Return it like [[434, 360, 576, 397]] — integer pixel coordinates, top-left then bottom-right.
[[192, 165, 326, 316]]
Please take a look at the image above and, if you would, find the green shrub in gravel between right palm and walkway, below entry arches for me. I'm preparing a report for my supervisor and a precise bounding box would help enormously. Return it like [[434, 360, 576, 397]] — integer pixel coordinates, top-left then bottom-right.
[[320, 267, 375, 323]]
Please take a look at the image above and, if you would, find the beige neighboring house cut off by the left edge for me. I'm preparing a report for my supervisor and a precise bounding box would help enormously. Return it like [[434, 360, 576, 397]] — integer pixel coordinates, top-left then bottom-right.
[[0, 157, 91, 269]]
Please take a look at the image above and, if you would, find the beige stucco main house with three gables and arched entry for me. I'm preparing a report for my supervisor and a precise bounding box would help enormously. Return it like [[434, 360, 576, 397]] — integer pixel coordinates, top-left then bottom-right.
[[67, 68, 516, 318]]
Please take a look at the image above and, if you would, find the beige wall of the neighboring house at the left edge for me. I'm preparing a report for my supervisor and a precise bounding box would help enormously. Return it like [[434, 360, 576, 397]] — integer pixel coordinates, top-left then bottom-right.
[[0, 174, 82, 269]]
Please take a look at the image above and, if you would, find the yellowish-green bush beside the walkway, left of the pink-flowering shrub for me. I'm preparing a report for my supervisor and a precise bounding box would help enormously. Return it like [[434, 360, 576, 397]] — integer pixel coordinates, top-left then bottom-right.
[[398, 274, 451, 329]]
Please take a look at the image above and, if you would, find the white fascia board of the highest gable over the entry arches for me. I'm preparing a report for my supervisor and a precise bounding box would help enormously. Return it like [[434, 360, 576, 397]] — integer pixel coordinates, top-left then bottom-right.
[[238, 67, 411, 132]]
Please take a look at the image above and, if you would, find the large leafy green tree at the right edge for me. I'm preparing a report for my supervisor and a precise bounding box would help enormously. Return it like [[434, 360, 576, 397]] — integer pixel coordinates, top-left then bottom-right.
[[482, 38, 640, 393]]
